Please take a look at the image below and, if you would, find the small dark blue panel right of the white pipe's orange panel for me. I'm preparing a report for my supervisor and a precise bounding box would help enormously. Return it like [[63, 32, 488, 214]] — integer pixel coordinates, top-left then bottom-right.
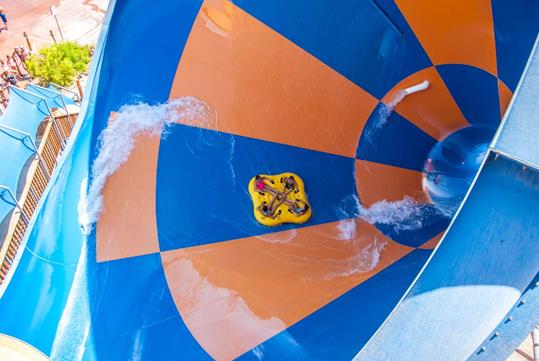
[[436, 64, 500, 129]]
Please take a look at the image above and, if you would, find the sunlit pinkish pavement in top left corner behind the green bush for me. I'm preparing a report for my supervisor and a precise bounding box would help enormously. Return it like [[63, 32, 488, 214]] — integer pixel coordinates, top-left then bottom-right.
[[0, 0, 109, 58]]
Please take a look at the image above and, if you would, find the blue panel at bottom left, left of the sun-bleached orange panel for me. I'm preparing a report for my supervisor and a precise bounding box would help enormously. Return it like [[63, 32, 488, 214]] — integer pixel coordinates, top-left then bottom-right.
[[86, 254, 211, 361]]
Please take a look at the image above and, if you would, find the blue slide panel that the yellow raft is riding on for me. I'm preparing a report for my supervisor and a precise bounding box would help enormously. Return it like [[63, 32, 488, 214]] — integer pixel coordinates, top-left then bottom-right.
[[156, 125, 357, 251]]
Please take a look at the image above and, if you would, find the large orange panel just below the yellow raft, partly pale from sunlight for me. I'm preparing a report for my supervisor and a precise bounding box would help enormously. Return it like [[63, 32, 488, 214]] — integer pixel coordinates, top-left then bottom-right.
[[161, 220, 412, 360]]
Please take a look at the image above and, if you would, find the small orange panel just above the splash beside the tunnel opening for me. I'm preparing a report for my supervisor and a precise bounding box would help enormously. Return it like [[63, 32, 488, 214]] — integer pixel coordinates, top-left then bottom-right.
[[355, 160, 428, 207]]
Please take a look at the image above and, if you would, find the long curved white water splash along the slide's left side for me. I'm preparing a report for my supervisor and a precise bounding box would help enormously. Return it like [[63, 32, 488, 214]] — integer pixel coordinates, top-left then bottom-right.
[[78, 97, 213, 234]]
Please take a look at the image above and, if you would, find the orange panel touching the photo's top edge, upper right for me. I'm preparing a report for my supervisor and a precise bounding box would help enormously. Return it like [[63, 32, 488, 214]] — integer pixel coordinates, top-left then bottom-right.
[[396, 0, 497, 76]]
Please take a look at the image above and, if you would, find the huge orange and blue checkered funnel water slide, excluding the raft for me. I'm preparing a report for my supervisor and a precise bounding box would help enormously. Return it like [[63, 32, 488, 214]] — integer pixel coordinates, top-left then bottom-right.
[[0, 0, 539, 361]]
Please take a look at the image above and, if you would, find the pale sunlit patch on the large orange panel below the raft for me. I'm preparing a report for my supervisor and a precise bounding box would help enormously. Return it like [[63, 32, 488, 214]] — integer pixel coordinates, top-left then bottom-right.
[[169, 258, 286, 360]]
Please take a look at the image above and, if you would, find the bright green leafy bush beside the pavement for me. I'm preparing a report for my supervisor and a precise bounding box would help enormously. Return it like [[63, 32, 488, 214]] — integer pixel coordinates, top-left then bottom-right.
[[26, 41, 91, 86]]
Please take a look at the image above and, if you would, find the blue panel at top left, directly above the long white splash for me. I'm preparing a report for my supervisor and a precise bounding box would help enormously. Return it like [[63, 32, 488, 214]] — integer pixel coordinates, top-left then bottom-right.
[[93, 0, 203, 153]]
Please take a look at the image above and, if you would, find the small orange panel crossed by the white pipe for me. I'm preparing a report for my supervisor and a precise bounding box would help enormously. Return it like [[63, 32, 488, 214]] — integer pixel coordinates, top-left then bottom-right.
[[382, 67, 468, 140]]
